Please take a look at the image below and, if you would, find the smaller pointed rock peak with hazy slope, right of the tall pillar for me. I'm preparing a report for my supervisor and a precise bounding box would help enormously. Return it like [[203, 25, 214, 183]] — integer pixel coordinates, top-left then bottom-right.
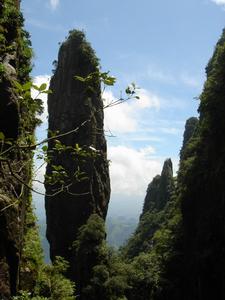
[[124, 159, 175, 258]]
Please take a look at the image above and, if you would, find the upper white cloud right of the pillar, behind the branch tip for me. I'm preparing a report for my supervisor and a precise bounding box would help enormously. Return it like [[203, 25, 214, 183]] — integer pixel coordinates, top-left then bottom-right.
[[103, 89, 160, 133]]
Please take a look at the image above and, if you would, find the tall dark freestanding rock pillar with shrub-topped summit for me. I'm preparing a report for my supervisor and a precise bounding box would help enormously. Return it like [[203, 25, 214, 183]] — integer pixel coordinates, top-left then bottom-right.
[[45, 31, 110, 279]]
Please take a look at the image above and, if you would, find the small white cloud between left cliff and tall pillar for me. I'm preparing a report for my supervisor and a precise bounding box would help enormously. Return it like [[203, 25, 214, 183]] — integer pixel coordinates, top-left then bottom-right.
[[31, 75, 50, 123]]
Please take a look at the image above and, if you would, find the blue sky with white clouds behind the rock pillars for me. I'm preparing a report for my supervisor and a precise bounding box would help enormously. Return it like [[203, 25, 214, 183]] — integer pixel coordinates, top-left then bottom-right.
[[21, 0, 225, 217]]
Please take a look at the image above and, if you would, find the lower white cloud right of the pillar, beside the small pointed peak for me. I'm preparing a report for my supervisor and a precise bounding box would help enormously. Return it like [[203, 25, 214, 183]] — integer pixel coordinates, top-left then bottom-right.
[[108, 145, 162, 196]]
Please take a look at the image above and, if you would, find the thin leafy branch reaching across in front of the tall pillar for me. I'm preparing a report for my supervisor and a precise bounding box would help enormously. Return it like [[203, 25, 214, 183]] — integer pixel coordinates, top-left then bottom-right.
[[0, 71, 139, 209]]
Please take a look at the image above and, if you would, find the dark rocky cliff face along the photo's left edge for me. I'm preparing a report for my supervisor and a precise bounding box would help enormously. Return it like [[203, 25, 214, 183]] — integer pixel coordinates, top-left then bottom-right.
[[0, 0, 40, 299]]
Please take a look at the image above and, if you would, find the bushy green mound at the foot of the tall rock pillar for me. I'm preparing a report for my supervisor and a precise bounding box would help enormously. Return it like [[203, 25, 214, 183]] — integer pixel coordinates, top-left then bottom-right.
[[74, 214, 128, 300]]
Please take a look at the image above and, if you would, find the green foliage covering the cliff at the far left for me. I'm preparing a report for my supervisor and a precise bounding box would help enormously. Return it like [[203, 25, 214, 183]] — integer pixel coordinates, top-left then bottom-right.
[[0, 0, 74, 299]]
